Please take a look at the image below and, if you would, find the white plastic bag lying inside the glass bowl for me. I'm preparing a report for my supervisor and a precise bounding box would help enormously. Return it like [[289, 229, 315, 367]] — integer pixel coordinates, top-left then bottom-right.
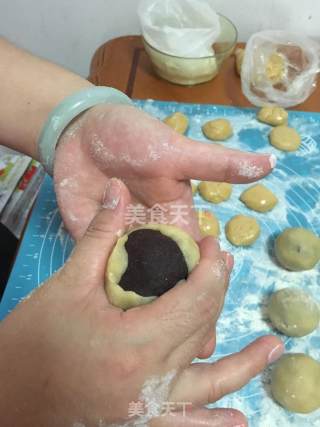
[[138, 0, 220, 58]]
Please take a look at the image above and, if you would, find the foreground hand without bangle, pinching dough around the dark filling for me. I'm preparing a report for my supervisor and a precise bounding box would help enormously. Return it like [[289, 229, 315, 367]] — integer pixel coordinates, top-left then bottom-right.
[[0, 179, 282, 427]]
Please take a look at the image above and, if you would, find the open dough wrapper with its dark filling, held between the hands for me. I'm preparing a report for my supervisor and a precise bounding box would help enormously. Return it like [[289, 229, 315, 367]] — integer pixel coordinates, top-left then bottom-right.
[[105, 224, 200, 310]]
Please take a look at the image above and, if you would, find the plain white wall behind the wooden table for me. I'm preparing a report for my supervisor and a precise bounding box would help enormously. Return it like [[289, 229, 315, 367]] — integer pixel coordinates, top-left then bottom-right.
[[0, 0, 320, 76]]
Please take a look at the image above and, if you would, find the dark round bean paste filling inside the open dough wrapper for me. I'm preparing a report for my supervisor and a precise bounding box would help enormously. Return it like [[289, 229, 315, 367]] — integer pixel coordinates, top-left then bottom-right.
[[119, 229, 188, 297]]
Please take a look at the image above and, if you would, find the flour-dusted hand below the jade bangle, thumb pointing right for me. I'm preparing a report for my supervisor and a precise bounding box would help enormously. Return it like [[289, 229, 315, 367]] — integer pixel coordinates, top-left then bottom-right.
[[54, 105, 274, 239]]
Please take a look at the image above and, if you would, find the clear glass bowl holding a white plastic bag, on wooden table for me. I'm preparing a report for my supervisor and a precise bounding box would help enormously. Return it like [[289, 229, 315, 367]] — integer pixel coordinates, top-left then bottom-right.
[[142, 14, 238, 85]]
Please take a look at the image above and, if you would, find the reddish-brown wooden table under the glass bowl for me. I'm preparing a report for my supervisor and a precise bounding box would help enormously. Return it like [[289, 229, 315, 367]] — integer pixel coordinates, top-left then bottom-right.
[[89, 36, 320, 111]]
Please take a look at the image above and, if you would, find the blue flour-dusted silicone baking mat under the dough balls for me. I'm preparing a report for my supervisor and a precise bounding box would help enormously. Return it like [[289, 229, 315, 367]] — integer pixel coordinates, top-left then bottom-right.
[[0, 100, 320, 427]]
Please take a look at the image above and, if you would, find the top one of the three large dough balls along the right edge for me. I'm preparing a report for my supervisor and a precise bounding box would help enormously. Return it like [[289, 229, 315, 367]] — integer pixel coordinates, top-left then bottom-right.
[[274, 227, 320, 271]]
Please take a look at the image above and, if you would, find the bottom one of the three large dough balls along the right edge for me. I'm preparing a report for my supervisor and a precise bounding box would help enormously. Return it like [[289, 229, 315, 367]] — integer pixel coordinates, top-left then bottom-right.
[[271, 353, 320, 414]]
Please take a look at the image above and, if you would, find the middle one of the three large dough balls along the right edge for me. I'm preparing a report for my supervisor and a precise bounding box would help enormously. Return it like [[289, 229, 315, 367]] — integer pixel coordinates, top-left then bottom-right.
[[268, 288, 320, 337]]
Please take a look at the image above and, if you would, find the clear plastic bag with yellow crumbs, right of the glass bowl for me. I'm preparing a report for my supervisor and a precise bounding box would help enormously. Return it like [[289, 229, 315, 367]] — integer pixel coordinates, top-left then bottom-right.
[[241, 31, 320, 107]]
